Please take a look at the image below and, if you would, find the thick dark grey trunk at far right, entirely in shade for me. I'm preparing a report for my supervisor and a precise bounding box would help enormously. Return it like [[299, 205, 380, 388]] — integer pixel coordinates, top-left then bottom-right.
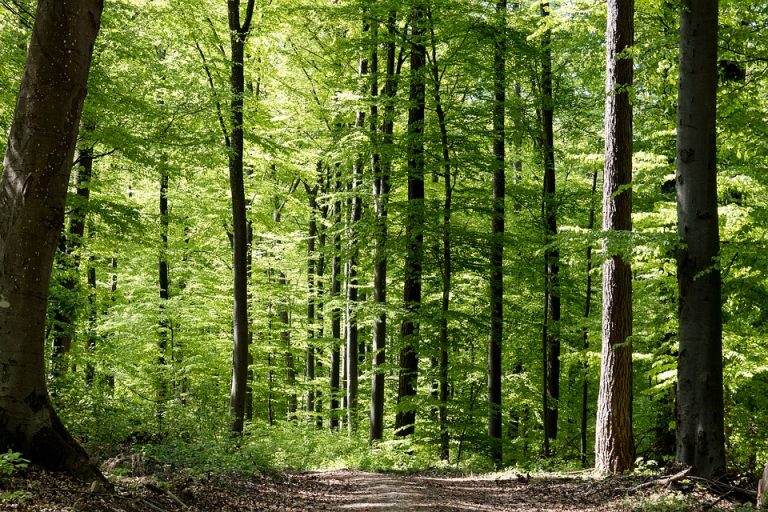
[[677, 0, 725, 477]]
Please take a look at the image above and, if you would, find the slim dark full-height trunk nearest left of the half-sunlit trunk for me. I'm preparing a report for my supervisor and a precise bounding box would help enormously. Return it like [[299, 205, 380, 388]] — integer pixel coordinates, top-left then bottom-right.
[[541, 0, 560, 439]]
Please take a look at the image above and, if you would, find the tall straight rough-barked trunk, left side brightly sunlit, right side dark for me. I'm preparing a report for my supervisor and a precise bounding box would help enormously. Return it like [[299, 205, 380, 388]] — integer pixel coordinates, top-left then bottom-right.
[[595, 0, 635, 473]]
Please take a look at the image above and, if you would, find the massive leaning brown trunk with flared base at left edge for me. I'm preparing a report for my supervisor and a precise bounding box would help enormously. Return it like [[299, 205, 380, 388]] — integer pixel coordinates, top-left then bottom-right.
[[0, 0, 106, 482]]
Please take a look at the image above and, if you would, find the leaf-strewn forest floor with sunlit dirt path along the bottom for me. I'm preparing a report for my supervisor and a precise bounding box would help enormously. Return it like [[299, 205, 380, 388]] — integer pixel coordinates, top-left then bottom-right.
[[0, 468, 748, 512]]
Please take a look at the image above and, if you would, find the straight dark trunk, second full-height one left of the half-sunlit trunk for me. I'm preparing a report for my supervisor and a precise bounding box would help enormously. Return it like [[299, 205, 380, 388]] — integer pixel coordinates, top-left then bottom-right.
[[488, 0, 507, 466]]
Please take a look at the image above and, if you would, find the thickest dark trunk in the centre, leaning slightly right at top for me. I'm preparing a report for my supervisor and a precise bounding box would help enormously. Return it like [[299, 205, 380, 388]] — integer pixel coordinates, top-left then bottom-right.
[[395, 2, 426, 436]]
